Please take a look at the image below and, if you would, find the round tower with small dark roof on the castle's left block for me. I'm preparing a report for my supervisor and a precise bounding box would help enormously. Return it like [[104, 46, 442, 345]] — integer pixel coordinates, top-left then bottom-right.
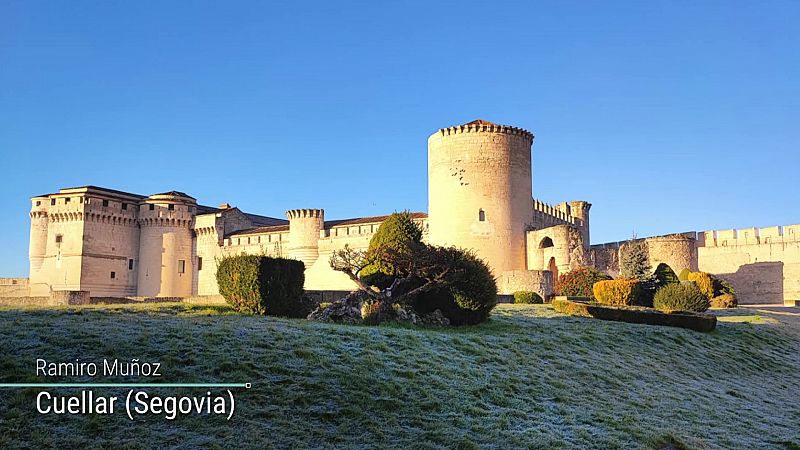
[[137, 191, 197, 297]]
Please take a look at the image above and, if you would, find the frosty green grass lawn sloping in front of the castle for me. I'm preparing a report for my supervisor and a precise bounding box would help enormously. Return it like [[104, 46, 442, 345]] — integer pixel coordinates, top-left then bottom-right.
[[0, 304, 800, 449]]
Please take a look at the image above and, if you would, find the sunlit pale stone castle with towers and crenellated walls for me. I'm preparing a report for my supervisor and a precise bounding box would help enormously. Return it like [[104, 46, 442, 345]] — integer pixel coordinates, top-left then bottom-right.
[[20, 120, 800, 304]]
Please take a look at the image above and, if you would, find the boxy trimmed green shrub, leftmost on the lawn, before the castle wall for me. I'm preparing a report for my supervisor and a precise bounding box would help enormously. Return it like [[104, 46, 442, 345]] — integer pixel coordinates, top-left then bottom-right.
[[217, 255, 311, 317]]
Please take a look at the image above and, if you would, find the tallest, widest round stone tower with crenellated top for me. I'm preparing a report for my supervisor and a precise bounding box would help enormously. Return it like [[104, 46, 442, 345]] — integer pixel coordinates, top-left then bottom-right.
[[428, 120, 533, 276]]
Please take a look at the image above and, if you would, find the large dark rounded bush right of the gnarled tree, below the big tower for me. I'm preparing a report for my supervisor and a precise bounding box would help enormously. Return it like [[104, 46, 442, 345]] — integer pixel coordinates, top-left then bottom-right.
[[412, 246, 497, 325]]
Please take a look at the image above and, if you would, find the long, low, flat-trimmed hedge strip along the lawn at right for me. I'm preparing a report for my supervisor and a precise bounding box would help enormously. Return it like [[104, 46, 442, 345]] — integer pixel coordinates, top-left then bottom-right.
[[553, 298, 717, 331]]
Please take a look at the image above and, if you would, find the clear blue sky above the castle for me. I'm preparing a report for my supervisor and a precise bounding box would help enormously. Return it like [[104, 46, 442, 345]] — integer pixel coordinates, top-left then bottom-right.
[[0, 0, 800, 276]]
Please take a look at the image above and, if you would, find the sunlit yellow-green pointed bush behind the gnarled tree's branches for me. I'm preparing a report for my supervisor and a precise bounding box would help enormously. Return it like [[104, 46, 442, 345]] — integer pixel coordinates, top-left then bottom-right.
[[360, 211, 422, 289]]
